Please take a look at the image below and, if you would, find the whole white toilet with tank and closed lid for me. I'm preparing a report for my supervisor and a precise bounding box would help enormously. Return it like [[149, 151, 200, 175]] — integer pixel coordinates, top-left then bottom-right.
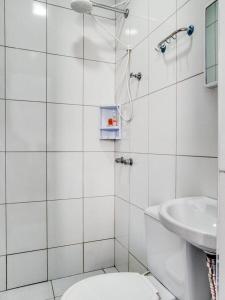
[[62, 206, 208, 300]]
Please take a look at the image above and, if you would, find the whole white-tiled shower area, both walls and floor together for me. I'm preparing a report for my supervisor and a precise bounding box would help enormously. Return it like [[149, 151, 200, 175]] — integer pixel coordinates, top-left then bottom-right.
[[0, 0, 218, 300]]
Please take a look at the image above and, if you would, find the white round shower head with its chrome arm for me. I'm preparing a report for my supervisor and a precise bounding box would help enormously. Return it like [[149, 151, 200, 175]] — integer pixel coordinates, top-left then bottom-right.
[[71, 0, 129, 18]]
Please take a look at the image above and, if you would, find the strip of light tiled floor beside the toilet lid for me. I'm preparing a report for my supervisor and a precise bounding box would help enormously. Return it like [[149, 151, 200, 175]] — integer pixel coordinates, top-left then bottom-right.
[[0, 268, 117, 300]]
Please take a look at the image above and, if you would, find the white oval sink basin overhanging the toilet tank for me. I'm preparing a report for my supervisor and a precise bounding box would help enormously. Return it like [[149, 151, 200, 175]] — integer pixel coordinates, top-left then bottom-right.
[[159, 197, 217, 253]]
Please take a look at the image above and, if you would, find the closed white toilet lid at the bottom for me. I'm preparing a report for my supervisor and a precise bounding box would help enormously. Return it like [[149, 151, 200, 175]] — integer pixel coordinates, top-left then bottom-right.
[[62, 273, 160, 300]]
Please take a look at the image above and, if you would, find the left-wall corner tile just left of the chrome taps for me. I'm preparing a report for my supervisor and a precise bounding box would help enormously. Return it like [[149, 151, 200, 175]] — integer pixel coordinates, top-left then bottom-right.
[[84, 152, 114, 197]]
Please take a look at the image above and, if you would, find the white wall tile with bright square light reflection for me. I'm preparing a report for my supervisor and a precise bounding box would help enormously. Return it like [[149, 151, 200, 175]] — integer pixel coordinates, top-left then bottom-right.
[[5, 0, 47, 51]]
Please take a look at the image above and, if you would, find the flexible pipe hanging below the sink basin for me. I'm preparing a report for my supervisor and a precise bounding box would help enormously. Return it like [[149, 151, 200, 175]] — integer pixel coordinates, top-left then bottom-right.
[[206, 254, 217, 300]]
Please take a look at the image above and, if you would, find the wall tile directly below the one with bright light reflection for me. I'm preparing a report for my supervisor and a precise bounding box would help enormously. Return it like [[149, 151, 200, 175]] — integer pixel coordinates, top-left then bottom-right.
[[6, 48, 46, 102]]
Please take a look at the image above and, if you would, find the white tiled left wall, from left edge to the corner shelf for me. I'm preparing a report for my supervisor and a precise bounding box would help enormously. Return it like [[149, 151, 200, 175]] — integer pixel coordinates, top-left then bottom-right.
[[0, 0, 115, 291]]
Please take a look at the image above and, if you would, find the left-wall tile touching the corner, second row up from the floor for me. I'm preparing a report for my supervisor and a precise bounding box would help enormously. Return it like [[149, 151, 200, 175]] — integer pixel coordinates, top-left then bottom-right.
[[84, 196, 114, 242]]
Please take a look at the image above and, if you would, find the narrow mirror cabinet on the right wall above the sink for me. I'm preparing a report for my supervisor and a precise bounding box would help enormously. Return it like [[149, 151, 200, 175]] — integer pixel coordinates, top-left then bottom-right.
[[205, 0, 218, 88]]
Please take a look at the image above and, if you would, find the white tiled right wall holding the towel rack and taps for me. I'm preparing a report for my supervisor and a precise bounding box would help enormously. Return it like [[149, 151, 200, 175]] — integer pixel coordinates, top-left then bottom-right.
[[115, 0, 218, 271]]
